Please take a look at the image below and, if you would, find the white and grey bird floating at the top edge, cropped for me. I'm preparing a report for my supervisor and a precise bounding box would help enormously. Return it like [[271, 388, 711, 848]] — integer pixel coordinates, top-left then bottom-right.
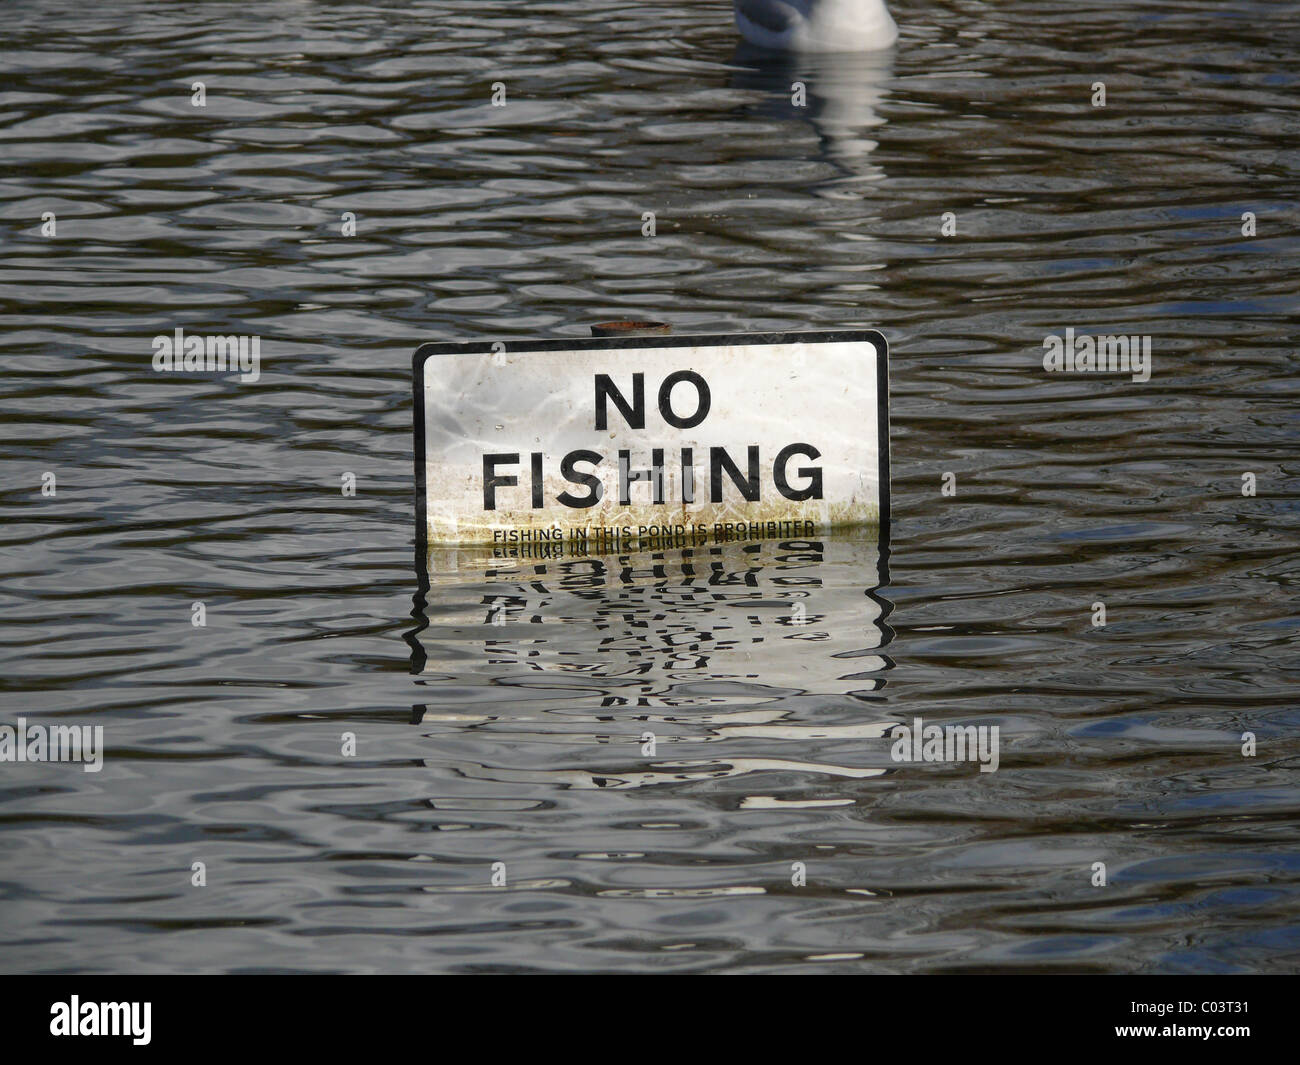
[[732, 0, 898, 52]]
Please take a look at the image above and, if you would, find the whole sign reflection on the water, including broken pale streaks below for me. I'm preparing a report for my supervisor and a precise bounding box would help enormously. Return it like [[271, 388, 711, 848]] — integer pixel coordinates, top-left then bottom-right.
[[411, 534, 894, 790]]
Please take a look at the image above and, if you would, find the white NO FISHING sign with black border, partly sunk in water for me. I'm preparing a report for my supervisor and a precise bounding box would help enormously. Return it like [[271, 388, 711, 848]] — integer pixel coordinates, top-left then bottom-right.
[[413, 330, 889, 551]]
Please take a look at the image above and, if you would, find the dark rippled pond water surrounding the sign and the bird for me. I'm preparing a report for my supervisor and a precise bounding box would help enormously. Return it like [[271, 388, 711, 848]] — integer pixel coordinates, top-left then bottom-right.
[[0, 0, 1300, 973]]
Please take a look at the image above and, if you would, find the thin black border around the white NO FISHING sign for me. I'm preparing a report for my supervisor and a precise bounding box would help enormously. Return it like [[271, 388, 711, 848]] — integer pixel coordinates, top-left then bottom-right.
[[411, 329, 891, 566]]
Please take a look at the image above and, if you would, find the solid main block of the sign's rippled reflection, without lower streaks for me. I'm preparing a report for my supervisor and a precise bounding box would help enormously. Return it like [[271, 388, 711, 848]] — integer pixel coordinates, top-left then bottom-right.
[[411, 533, 889, 707]]
